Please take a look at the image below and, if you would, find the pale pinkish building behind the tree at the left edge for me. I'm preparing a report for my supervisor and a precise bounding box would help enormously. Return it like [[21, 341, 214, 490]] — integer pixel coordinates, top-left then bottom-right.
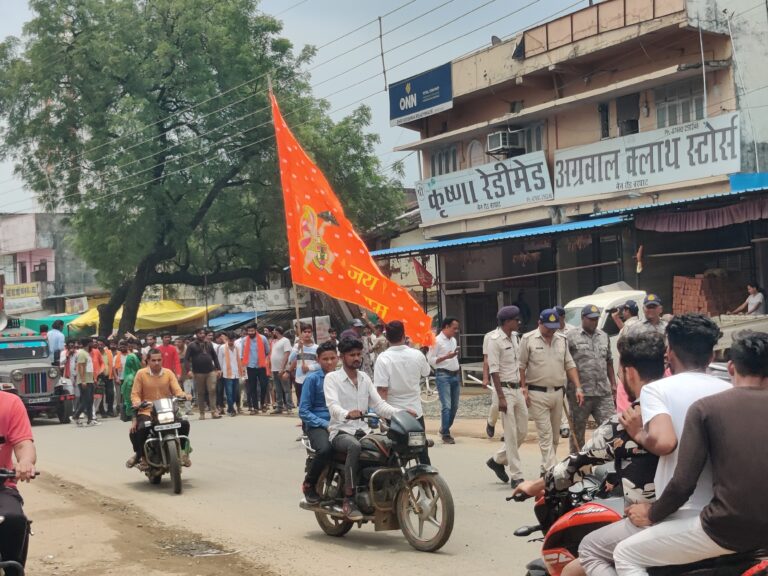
[[0, 213, 104, 316]]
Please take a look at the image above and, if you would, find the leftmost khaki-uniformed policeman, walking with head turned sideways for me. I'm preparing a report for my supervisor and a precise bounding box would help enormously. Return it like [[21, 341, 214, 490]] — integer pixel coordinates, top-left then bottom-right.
[[486, 306, 528, 489]]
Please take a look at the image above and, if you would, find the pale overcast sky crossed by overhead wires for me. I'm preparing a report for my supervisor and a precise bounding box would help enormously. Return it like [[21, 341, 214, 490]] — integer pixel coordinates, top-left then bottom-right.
[[0, 0, 588, 212]]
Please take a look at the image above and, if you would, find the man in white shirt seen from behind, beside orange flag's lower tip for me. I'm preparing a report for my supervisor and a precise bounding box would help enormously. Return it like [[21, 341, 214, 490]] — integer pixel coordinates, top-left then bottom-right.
[[373, 320, 432, 464]]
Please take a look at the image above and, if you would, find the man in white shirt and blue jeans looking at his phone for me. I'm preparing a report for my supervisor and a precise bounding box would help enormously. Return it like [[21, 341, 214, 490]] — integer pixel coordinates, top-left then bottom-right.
[[427, 316, 461, 444]]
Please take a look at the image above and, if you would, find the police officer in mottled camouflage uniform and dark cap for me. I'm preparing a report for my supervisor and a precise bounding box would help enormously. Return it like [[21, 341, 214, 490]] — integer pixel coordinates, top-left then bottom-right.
[[566, 304, 616, 449]]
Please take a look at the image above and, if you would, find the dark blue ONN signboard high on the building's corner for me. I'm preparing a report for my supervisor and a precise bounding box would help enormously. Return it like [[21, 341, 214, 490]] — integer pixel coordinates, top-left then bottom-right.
[[388, 62, 453, 126]]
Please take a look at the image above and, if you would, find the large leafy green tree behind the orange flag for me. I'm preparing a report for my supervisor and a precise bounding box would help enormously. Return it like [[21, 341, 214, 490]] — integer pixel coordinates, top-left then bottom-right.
[[0, 0, 402, 332]]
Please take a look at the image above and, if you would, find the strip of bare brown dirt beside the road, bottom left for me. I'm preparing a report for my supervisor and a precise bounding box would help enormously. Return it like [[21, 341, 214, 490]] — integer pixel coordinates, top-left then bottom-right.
[[22, 476, 274, 576]]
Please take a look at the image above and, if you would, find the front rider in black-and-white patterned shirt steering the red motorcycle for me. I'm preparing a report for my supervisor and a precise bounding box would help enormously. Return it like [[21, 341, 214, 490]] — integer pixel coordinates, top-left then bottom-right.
[[513, 332, 665, 576]]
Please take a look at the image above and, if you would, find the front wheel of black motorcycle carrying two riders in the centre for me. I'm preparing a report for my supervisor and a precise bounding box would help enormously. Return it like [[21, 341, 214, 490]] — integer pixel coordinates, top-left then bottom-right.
[[395, 474, 454, 552]]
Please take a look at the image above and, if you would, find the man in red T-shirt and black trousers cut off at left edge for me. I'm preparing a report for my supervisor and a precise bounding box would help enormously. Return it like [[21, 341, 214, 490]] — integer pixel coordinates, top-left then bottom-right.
[[0, 384, 37, 564]]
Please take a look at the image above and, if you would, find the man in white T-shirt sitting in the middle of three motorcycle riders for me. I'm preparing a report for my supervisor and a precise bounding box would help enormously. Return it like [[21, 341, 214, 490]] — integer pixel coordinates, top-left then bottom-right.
[[583, 314, 731, 576]]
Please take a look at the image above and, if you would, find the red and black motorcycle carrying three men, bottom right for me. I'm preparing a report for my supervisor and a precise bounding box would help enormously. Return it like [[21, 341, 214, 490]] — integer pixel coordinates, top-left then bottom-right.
[[507, 476, 768, 576]]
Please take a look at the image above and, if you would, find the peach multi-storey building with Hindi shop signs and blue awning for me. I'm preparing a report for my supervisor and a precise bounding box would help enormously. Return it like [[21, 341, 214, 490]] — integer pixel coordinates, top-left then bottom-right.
[[375, 0, 768, 352]]
